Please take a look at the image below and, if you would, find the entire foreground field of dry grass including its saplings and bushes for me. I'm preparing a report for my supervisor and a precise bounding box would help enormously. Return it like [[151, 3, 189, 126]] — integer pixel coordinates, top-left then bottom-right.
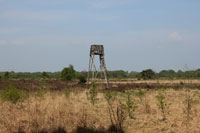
[[0, 80, 200, 133]]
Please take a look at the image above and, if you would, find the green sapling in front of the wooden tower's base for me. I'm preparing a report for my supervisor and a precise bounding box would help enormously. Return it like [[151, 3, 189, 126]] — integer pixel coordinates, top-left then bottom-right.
[[86, 82, 98, 105]]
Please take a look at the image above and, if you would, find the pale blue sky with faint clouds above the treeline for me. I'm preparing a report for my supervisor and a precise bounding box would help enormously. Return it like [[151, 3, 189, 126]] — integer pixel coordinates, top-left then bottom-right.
[[0, 0, 200, 72]]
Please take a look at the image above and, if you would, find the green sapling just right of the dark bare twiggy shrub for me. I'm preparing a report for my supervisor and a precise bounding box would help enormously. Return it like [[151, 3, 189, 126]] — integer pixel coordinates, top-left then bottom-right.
[[126, 91, 137, 118]]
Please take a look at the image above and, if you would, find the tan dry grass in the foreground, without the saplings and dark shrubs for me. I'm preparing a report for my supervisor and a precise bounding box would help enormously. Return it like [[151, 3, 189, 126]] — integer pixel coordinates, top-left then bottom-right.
[[0, 89, 200, 133]]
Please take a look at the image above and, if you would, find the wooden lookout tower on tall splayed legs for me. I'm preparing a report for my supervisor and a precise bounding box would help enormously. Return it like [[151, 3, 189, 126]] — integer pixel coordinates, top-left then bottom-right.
[[88, 45, 109, 88]]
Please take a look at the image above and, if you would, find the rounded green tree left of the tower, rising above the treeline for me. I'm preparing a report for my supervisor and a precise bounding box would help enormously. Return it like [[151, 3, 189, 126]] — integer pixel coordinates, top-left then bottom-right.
[[61, 65, 76, 80]]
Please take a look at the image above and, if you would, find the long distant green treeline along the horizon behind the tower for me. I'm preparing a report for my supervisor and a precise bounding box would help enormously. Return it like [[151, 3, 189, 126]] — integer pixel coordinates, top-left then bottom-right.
[[0, 65, 200, 80]]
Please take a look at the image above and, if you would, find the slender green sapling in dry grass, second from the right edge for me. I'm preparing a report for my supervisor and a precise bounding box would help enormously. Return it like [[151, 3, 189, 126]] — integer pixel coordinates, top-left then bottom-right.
[[156, 91, 167, 120]]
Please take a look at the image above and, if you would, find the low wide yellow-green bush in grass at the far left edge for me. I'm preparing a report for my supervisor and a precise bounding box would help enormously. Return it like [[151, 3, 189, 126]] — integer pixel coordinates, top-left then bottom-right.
[[1, 85, 27, 104]]
